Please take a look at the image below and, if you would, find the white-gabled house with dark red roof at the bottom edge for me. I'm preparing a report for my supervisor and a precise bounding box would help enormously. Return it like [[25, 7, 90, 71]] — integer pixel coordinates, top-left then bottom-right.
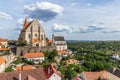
[[44, 65, 62, 80]]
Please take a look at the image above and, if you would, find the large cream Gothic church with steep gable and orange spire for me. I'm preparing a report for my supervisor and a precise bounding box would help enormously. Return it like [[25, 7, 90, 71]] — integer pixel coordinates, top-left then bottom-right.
[[19, 18, 46, 47]]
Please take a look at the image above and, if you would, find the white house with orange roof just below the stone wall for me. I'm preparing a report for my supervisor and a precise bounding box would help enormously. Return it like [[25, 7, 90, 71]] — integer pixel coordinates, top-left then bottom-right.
[[23, 52, 45, 64]]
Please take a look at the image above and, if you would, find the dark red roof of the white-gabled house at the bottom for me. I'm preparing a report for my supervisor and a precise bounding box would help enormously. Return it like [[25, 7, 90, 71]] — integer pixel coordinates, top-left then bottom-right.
[[44, 64, 61, 79]]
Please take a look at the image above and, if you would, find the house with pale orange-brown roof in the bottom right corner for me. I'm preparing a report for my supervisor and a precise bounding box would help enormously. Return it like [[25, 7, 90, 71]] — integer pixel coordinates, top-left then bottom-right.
[[80, 70, 120, 80]]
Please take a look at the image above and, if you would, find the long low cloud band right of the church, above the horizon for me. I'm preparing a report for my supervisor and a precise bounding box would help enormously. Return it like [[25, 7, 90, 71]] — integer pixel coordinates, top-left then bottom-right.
[[53, 23, 106, 33]]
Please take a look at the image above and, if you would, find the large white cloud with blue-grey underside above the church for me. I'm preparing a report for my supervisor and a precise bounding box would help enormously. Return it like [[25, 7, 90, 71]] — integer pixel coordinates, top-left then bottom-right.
[[24, 2, 63, 22]]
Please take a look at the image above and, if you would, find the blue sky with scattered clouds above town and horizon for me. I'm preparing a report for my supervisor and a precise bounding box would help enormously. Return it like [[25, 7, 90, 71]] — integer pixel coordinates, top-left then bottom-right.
[[0, 0, 120, 40]]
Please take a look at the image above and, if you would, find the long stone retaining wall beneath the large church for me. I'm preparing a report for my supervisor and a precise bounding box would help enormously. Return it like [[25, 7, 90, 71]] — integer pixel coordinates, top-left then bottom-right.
[[16, 46, 55, 56]]
